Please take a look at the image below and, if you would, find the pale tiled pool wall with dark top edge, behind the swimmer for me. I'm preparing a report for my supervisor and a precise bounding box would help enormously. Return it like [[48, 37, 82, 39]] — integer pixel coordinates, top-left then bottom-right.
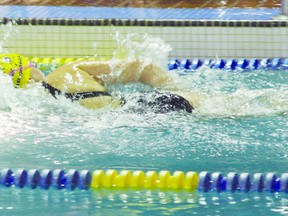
[[0, 6, 288, 59]]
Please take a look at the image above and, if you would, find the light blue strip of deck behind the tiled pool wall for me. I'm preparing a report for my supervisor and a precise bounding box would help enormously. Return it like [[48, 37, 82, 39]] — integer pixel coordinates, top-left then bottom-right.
[[0, 5, 280, 21]]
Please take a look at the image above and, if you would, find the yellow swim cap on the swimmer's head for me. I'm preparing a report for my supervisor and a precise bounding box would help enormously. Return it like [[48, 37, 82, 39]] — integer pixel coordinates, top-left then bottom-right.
[[0, 53, 30, 88]]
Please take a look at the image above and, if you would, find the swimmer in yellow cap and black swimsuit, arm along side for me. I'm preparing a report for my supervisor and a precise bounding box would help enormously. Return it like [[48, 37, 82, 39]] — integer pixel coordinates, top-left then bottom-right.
[[0, 54, 199, 113]]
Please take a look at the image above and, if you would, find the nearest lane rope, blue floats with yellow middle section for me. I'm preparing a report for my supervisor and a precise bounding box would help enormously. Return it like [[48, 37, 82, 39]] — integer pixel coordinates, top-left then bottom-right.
[[0, 168, 288, 194]]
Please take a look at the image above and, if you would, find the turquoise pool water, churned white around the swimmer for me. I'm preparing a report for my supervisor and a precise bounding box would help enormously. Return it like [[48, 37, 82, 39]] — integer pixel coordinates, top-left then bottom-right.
[[0, 60, 288, 215]]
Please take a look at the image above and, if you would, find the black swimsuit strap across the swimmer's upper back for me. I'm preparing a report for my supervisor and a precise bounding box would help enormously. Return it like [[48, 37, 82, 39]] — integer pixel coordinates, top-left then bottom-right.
[[42, 82, 111, 101]]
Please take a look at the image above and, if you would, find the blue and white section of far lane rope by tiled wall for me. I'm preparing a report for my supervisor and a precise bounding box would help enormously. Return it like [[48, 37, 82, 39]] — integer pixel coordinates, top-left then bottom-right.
[[168, 58, 288, 71]]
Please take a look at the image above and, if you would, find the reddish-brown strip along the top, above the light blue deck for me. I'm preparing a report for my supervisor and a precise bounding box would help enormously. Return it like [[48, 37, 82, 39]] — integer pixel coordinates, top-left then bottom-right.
[[0, 0, 281, 8]]
